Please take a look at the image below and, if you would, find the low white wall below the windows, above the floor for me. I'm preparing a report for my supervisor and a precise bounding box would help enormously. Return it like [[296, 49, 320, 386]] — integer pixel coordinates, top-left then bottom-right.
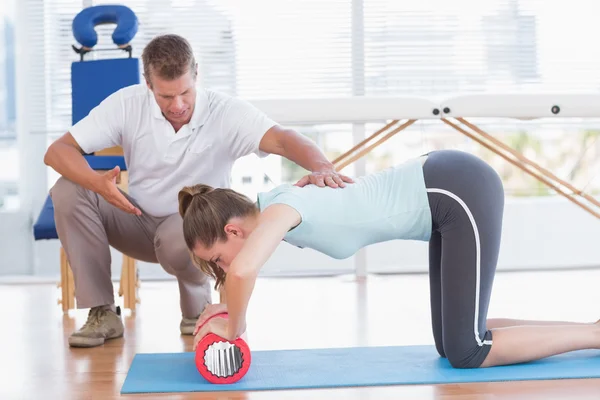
[[0, 196, 600, 279]]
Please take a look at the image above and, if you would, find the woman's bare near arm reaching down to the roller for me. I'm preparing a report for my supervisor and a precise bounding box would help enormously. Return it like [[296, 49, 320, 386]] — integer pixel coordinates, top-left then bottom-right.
[[224, 204, 301, 340]]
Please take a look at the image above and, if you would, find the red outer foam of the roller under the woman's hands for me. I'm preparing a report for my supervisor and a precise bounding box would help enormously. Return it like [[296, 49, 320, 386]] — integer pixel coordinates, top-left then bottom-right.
[[195, 313, 252, 384]]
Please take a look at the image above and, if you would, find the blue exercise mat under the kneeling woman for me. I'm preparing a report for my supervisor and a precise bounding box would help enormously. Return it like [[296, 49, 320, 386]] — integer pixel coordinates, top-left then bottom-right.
[[121, 346, 600, 394]]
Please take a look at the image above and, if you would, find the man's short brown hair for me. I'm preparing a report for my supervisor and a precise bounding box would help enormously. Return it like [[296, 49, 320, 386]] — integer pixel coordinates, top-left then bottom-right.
[[142, 34, 196, 81]]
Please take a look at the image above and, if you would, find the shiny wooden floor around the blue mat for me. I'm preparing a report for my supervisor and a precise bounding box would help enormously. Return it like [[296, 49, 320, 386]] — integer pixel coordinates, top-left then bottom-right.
[[0, 270, 600, 400]]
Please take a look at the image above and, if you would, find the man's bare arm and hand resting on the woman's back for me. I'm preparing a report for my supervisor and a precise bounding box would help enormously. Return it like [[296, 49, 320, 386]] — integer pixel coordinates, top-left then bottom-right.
[[259, 125, 353, 187]]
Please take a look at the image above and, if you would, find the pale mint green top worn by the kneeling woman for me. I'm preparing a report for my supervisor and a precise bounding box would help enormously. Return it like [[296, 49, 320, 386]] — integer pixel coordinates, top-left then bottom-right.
[[257, 159, 431, 259]]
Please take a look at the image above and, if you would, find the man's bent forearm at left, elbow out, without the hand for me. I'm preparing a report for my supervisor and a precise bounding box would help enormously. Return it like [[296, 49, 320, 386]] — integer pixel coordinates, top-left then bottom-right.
[[44, 142, 99, 192]]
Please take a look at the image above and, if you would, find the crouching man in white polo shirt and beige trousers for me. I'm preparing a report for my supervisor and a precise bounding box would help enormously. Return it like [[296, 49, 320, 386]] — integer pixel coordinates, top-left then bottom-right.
[[44, 35, 352, 347]]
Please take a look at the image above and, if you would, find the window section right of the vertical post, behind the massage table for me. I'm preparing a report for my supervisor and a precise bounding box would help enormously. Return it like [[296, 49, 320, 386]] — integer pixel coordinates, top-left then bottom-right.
[[356, 0, 600, 196]]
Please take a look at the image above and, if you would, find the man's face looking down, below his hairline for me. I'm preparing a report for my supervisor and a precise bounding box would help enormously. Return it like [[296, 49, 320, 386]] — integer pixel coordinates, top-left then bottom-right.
[[147, 67, 196, 125]]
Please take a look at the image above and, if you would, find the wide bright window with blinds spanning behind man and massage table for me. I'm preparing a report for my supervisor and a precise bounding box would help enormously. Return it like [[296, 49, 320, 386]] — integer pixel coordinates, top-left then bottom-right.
[[25, 0, 600, 200]]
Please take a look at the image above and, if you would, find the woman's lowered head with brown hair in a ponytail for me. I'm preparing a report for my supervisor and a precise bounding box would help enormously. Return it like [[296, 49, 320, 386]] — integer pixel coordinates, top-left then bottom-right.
[[178, 184, 258, 287]]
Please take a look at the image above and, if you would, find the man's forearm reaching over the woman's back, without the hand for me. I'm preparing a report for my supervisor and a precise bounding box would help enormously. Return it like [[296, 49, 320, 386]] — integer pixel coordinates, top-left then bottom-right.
[[282, 130, 335, 172]]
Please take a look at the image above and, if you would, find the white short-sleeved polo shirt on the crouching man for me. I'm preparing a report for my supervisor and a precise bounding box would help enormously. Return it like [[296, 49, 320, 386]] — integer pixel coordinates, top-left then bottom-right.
[[70, 83, 276, 217]]
